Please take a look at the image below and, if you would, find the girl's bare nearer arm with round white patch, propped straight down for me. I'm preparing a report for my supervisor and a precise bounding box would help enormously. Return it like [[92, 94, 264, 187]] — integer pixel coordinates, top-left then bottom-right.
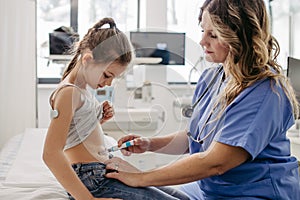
[[43, 87, 93, 200]]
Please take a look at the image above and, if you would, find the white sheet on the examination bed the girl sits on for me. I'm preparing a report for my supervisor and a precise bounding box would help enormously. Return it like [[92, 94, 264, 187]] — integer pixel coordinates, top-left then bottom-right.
[[0, 129, 120, 200]]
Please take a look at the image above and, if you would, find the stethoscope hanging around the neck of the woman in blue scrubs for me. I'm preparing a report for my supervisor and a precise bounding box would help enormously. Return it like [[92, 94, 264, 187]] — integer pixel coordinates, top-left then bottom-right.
[[182, 67, 223, 144]]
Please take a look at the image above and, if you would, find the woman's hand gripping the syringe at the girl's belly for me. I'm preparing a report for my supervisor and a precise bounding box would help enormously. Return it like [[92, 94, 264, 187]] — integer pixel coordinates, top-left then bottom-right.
[[118, 135, 151, 156]]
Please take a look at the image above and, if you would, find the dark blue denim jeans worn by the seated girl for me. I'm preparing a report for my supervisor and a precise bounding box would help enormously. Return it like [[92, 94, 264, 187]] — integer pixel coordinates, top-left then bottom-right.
[[69, 162, 189, 200]]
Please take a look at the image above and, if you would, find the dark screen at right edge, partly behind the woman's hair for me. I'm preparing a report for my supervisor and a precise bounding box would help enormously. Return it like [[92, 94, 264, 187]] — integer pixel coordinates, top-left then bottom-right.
[[287, 57, 300, 119]]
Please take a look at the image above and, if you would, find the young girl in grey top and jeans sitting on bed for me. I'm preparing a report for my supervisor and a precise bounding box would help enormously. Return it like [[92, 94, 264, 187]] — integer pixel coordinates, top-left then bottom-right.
[[43, 18, 186, 200]]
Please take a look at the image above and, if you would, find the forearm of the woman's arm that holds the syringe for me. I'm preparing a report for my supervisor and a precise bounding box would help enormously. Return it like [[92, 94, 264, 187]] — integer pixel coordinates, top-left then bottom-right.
[[148, 131, 189, 155]]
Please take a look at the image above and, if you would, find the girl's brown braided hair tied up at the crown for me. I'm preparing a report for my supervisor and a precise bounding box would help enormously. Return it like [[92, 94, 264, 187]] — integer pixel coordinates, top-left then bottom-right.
[[62, 18, 132, 80]]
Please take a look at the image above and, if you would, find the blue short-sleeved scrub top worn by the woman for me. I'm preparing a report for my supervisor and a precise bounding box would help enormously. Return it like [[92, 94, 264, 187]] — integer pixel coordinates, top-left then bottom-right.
[[189, 66, 300, 200]]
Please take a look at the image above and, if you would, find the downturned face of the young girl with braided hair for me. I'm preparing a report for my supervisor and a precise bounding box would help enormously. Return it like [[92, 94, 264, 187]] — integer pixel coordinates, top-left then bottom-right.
[[86, 63, 126, 89]]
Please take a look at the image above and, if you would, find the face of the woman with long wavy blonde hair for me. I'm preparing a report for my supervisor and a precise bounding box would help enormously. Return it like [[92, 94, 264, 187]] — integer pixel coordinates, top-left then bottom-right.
[[200, 11, 229, 63]]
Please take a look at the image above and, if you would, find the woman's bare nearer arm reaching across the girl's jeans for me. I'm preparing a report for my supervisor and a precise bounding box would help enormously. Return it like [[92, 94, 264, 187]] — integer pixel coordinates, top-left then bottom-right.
[[106, 142, 250, 187]]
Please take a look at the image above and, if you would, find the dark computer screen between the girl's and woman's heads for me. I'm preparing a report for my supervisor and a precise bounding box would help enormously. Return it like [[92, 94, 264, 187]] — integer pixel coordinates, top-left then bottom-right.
[[130, 31, 185, 65]]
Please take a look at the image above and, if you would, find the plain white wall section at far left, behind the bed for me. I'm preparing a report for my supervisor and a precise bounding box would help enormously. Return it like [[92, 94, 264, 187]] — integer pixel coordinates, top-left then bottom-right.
[[0, 0, 36, 148]]
